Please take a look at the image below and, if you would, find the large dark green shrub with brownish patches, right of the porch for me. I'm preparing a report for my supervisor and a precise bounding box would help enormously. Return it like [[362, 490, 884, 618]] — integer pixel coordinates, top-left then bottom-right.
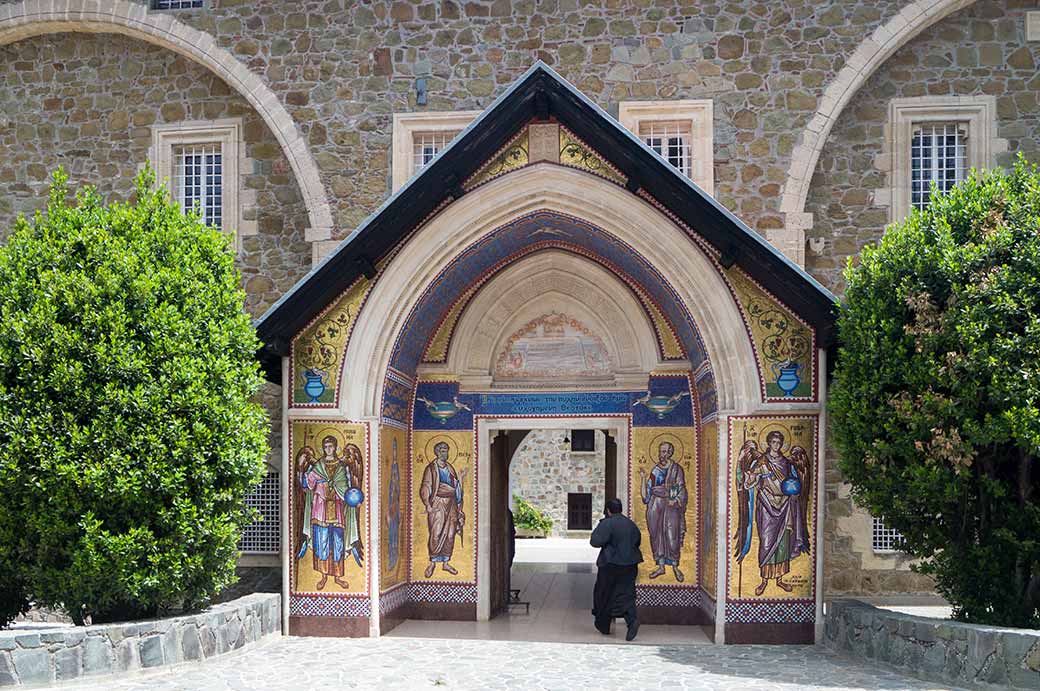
[[830, 159, 1040, 626]]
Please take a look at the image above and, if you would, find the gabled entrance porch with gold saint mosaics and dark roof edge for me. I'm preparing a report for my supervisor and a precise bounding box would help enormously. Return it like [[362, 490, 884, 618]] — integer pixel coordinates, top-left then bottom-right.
[[258, 66, 833, 642]]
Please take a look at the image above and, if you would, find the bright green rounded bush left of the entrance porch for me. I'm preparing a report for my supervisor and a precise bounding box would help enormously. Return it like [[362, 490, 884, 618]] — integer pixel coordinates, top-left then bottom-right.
[[0, 171, 267, 622]]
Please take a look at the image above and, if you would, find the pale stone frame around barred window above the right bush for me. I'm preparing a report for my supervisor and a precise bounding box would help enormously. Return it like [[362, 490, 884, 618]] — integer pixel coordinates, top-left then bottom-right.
[[876, 96, 1007, 222]]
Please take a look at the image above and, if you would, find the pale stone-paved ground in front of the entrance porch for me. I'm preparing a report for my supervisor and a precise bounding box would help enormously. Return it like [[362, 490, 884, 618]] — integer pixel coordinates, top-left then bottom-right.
[[40, 638, 948, 691]]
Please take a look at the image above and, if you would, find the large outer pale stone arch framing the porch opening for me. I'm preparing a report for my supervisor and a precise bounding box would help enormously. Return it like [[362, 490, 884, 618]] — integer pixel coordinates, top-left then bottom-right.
[[339, 163, 761, 419]]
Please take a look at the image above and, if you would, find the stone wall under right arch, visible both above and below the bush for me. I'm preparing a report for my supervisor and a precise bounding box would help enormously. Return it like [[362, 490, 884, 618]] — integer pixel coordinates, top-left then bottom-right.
[[806, 0, 1040, 594]]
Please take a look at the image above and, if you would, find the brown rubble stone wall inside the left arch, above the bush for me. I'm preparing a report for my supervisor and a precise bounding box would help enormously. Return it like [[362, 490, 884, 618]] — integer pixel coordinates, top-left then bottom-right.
[[0, 33, 311, 316]]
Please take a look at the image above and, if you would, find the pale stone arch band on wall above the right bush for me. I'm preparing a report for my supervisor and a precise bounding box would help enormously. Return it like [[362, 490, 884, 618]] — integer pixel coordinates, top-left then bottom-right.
[[769, 0, 976, 265]]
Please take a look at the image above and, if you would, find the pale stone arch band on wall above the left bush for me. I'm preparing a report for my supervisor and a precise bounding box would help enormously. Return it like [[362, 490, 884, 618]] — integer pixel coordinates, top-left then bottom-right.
[[0, 0, 333, 248]]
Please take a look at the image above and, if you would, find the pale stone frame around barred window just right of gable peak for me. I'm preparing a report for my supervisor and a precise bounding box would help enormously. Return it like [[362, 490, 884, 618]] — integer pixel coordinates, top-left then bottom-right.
[[618, 99, 714, 196]]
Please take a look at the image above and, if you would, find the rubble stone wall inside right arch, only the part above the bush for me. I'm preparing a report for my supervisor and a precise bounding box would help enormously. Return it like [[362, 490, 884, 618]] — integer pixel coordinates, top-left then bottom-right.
[[806, 0, 1040, 293]]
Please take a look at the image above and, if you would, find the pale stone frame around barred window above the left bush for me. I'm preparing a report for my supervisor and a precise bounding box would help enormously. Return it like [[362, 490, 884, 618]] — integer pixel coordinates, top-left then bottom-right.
[[151, 118, 242, 240]]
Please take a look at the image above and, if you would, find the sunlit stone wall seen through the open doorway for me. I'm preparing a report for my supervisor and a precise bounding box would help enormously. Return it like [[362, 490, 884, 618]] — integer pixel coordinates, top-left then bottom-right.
[[510, 430, 606, 536]]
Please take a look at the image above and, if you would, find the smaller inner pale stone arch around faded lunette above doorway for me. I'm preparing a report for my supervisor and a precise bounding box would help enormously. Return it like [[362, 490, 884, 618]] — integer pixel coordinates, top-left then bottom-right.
[[420, 249, 690, 390]]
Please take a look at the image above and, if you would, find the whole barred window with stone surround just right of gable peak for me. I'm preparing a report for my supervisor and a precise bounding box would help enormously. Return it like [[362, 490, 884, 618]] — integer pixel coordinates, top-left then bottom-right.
[[618, 99, 714, 195]]
